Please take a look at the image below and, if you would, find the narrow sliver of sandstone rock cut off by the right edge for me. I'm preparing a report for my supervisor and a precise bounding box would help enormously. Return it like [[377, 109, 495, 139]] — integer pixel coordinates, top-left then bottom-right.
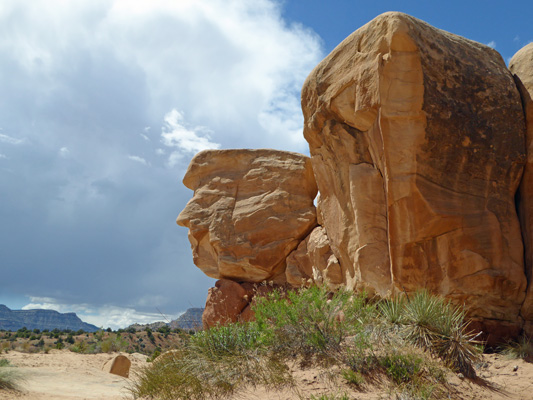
[[509, 43, 533, 336]]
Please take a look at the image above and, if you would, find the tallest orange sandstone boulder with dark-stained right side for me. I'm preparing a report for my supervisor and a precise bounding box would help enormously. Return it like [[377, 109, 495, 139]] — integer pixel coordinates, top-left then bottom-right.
[[302, 13, 526, 327]]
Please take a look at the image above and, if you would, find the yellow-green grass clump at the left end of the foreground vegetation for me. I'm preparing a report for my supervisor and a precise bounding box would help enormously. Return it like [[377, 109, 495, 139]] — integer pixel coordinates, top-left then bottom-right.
[[131, 324, 292, 400]]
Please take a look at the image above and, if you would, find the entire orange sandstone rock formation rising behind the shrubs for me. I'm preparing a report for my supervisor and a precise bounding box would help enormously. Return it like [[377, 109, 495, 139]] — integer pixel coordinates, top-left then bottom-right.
[[177, 12, 533, 342]]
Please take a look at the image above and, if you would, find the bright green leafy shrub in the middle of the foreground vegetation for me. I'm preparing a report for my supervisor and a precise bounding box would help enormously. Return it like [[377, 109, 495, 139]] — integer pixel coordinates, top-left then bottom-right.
[[253, 286, 375, 363]]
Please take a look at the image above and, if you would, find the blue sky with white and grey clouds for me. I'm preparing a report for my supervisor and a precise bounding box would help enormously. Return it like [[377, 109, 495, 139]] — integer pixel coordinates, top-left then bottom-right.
[[0, 0, 533, 329]]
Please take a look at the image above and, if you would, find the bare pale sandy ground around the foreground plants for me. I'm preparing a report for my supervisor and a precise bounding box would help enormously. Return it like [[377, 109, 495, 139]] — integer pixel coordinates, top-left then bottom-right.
[[0, 350, 533, 400]]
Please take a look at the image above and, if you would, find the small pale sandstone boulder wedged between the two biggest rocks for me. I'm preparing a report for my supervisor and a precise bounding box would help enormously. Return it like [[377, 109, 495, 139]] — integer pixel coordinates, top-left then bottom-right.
[[285, 226, 344, 288]]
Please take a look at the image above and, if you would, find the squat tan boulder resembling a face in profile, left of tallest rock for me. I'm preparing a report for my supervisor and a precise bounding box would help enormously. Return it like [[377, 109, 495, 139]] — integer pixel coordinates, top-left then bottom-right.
[[177, 150, 317, 282]]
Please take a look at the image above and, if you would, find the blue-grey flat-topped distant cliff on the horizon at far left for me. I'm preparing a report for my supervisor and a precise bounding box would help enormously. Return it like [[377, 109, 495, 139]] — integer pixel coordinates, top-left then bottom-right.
[[0, 304, 99, 332]]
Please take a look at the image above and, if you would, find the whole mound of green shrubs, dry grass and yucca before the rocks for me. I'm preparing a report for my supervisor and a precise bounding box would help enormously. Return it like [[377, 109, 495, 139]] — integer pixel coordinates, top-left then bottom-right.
[[132, 287, 494, 400]]
